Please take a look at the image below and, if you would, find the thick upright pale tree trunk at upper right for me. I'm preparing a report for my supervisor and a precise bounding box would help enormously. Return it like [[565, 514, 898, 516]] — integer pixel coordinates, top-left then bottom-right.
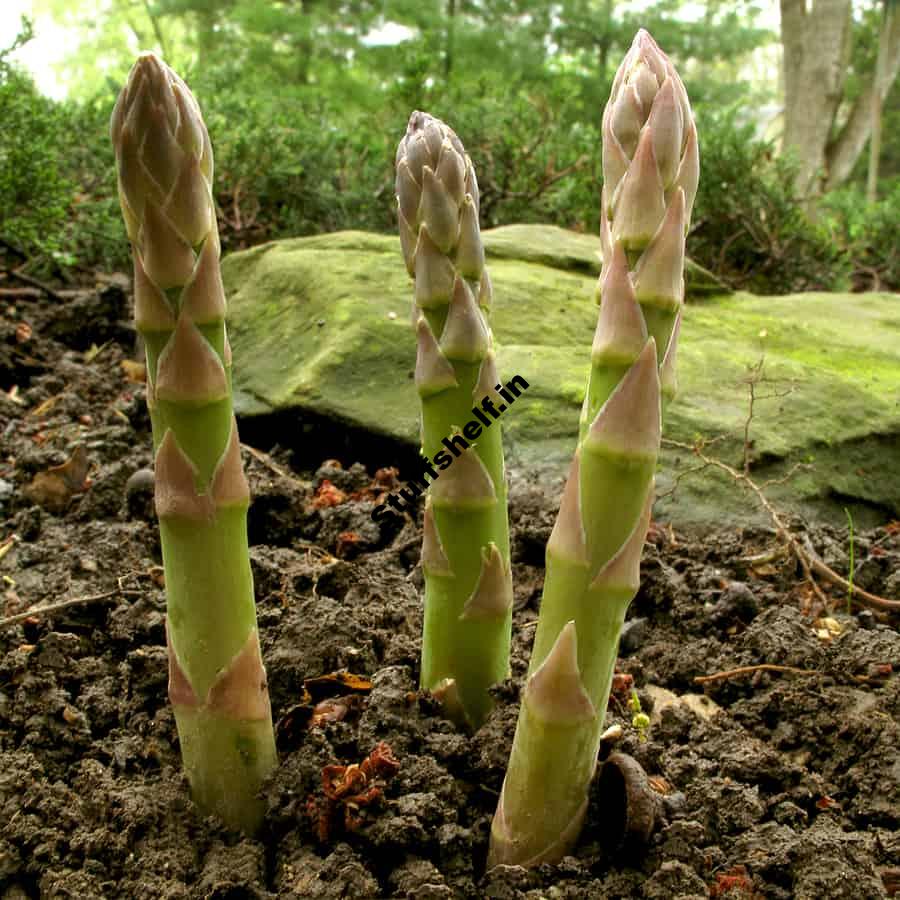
[[781, 0, 852, 197]]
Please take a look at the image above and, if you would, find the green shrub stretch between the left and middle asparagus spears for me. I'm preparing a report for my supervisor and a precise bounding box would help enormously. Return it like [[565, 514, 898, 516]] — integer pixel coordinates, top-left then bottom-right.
[[191, 67, 396, 249]]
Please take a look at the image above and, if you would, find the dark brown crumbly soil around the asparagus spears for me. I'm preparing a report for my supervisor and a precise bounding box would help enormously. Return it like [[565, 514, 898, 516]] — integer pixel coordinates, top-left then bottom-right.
[[0, 285, 900, 900]]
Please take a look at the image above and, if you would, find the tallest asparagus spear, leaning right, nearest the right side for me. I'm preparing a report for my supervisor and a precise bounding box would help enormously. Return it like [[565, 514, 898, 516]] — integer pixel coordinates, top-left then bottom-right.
[[488, 30, 699, 866]]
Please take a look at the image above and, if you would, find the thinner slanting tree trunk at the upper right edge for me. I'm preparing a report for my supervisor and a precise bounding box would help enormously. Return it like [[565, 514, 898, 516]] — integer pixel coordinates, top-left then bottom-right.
[[825, 0, 900, 190]]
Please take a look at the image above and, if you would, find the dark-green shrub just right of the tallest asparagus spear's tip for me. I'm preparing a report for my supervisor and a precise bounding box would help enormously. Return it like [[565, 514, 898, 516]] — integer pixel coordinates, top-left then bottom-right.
[[688, 110, 849, 294]]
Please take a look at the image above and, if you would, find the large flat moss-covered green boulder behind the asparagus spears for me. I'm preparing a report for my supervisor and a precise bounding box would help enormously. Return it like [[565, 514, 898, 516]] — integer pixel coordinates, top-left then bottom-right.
[[223, 225, 900, 524]]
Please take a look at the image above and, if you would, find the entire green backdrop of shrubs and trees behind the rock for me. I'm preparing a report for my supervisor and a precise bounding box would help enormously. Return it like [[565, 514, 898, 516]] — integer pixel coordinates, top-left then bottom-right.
[[0, 0, 900, 293]]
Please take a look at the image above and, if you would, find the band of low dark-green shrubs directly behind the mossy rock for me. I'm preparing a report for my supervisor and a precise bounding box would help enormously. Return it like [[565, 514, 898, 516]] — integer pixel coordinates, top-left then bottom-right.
[[0, 40, 900, 294]]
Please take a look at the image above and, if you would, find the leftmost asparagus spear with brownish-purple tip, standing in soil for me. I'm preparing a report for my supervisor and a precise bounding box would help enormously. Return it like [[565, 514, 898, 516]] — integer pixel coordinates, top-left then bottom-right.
[[110, 53, 277, 832]]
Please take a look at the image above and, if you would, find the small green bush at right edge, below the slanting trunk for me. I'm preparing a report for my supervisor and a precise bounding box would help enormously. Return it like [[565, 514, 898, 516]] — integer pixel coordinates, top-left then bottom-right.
[[822, 183, 900, 291]]
